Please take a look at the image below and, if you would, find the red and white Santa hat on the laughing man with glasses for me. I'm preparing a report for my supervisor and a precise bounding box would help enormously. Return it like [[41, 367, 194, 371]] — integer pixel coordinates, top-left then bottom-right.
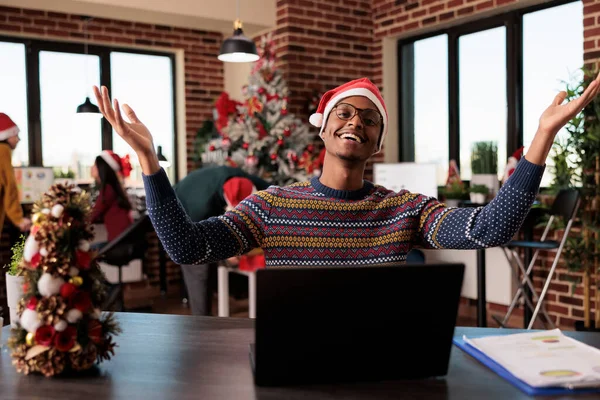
[[309, 78, 388, 153]]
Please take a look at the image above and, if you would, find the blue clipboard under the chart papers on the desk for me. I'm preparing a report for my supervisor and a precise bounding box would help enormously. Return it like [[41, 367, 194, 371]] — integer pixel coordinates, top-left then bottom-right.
[[452, 337, 600, 396]]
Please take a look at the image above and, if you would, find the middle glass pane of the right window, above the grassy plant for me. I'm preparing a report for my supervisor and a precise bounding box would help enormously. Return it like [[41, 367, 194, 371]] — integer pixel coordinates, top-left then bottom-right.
[[458, 27, 507, 180]]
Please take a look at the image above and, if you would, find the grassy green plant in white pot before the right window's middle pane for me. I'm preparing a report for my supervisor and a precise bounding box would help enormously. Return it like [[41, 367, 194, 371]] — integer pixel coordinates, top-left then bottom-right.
[[471, 142, 500, 195]]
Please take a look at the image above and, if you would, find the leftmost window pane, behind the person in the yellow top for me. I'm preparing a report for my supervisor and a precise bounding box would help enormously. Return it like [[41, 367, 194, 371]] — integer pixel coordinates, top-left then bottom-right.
[[0, 42, 29, 166]]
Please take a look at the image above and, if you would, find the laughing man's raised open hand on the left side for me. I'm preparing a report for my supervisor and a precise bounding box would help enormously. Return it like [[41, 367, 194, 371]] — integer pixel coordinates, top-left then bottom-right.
[[94, 86, 160, 175]]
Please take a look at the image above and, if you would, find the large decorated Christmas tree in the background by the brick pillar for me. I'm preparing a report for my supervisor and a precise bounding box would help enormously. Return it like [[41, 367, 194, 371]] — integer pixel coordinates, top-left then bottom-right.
[[203, 35, 322, 185]]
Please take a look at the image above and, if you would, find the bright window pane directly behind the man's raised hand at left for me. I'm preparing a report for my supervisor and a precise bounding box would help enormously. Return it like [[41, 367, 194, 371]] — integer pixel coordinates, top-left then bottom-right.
[[110, 52, 175, 182]]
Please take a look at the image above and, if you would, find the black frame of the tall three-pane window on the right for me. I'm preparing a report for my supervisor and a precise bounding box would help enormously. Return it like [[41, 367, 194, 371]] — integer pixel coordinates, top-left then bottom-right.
[[396, 0, 583, 184]]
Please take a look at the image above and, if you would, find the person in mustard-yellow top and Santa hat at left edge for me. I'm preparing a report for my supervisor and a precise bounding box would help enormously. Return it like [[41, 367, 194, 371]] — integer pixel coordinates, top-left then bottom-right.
[[0, 113, 31, 232]]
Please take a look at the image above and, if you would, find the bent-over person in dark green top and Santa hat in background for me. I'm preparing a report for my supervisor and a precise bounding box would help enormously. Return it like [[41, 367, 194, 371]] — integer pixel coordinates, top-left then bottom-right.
[[174, 166, 270, 315]]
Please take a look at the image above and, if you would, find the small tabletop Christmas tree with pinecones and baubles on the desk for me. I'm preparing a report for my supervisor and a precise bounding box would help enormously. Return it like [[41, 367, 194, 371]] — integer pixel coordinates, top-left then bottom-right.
[[9, 184, 120, 376]]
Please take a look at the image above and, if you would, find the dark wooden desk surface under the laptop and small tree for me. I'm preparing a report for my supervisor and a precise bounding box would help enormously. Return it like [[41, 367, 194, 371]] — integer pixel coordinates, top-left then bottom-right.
[[0, 313, 600, 400]]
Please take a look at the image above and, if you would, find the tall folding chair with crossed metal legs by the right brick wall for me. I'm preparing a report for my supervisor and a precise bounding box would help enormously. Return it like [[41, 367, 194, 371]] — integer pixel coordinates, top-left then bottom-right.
[[495, 189, 581, 329]]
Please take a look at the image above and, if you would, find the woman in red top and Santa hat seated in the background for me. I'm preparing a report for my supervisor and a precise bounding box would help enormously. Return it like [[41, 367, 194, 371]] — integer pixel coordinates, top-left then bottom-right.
[[90, 150, 133, 249]]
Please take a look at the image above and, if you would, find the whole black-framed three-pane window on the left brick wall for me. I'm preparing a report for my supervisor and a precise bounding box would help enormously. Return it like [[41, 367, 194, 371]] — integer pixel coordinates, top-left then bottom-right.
[[0, 37, 177, 186]]
